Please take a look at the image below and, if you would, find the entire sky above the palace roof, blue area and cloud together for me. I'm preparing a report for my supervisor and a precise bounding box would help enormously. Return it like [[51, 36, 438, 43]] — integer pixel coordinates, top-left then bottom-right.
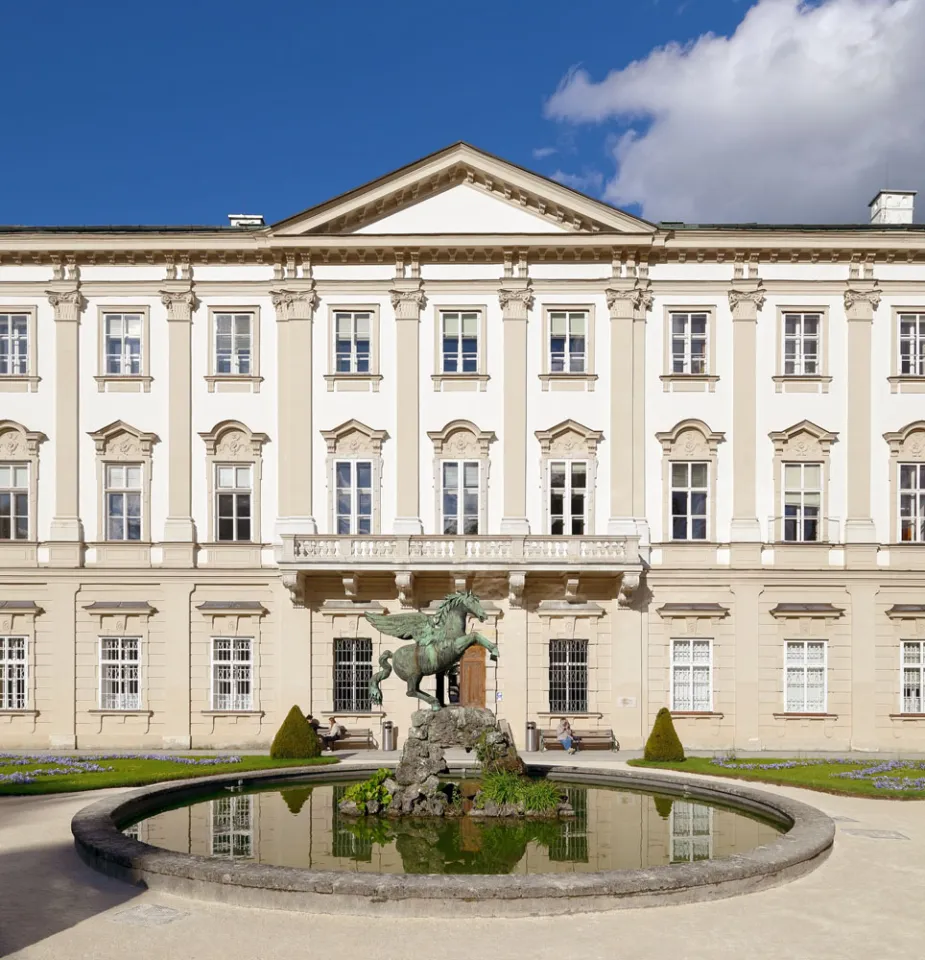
[[0, 0, 925, 225]]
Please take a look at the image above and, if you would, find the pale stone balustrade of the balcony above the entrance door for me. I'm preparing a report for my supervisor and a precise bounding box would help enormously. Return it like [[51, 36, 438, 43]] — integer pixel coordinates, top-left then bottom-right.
[[280, 534, 640, 570]]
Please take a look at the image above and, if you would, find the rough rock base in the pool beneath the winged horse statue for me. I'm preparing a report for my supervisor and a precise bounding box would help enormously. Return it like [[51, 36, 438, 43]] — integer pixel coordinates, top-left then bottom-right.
[[338, 707, 572, 817]]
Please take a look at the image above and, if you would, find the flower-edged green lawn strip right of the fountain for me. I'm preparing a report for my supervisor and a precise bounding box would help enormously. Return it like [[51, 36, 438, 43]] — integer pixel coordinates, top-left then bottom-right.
[[628, 757, 925, 800]]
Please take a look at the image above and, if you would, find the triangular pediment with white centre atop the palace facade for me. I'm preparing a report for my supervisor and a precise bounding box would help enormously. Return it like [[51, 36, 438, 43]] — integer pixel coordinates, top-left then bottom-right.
[[272, 143, 655, 236]]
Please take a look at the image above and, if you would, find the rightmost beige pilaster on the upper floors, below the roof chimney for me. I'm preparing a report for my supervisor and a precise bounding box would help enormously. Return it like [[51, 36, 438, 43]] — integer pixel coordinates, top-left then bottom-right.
[[845, 284, 880, 544]]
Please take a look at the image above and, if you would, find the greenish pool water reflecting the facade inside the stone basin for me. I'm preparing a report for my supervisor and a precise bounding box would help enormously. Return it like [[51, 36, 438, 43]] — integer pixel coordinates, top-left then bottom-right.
[[126, 784, 779, 874]]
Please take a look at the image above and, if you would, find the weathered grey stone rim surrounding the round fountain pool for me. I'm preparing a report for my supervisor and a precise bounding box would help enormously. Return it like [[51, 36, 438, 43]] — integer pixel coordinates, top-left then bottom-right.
[[71, 764, 835, 916]]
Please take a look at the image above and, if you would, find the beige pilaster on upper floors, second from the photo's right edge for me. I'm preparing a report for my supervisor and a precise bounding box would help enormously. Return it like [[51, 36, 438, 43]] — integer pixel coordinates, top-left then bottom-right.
[[728, 280, 764, 562]]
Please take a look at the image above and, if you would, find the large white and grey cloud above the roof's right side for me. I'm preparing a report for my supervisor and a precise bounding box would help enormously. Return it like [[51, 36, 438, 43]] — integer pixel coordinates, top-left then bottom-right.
[[546, 0, 925, 222]]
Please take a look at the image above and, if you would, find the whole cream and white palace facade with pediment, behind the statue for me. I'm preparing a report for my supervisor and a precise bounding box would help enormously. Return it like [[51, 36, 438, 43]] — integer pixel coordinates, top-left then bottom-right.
[[0, 144, 925, 751]]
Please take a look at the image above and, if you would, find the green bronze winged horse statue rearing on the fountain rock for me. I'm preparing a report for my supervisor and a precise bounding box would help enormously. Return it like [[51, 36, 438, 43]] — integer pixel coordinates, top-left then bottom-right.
[[366, 591, 498, 710]]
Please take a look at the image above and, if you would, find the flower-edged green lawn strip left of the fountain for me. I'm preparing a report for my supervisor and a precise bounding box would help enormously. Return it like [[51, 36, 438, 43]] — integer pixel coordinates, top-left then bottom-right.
[[0, 754, 337, 796]]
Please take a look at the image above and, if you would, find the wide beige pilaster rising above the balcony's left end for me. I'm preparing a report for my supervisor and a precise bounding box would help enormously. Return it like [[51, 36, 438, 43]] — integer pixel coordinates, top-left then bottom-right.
[[271, 280, 318, 540]]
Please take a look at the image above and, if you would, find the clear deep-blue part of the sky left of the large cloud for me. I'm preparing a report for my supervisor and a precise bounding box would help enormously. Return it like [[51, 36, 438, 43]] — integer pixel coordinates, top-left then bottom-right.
[[0, 0, 743, 224]]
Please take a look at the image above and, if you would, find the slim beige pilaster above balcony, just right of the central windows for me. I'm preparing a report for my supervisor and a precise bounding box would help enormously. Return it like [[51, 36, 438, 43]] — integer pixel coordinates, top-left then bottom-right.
[[498, 280, 533, 536]]
